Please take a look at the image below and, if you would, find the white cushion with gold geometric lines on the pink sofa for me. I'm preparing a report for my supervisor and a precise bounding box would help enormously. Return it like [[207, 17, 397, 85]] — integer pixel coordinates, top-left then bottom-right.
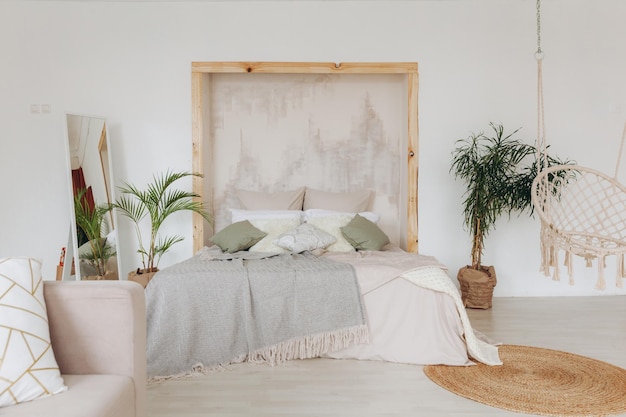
[[0, 257, 67, 407]]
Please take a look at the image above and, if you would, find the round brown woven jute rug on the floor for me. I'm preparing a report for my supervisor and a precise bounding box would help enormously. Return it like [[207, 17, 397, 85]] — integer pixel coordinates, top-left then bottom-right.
[[424, 345, 626, 417]]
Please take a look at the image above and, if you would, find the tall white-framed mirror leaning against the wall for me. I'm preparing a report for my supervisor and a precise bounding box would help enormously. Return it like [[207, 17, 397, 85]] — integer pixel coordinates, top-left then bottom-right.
[[63, 113, 120, 280]]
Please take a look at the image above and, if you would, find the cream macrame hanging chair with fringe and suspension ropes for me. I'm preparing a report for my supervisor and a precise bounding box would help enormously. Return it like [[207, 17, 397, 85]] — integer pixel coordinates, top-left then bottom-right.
[[531, 0, 626, 290]]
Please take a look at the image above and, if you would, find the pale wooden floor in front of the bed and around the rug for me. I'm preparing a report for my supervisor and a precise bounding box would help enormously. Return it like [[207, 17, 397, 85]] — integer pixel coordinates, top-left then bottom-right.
[[148, 296, 626, 417]]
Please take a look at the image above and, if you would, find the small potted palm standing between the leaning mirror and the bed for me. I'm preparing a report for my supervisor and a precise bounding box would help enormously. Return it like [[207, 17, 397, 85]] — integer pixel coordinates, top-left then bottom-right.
[[113, 171, 211, 287]]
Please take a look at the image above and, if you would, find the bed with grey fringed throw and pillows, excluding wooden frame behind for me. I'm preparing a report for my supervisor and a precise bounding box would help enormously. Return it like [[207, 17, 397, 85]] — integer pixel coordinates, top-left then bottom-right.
[[146, 197, 499, 379]]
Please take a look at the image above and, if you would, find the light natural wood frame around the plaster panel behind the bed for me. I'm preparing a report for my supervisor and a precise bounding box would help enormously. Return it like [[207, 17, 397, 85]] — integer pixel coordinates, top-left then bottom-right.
[[191, 62, 419, 253]]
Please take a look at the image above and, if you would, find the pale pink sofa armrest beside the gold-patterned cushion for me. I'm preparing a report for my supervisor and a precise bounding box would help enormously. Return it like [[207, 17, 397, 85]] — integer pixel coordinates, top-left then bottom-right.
[[44, 281, 146, 416]]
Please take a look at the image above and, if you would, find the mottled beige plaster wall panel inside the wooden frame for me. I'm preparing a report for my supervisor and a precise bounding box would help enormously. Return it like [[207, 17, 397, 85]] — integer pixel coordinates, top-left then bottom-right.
[[205, 74, 407, 243]]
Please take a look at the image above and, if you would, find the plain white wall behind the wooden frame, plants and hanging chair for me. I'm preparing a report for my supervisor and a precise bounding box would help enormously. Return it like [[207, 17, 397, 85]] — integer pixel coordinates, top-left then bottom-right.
[[0, 0, 626, 296]]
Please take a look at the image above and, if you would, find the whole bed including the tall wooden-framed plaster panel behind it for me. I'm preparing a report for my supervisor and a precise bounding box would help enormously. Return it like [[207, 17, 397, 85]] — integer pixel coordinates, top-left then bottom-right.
[[140, 62, 500, 377]]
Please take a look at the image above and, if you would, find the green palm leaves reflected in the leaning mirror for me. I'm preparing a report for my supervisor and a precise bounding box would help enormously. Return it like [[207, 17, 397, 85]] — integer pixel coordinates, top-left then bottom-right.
[[74, 189, 117, 280]]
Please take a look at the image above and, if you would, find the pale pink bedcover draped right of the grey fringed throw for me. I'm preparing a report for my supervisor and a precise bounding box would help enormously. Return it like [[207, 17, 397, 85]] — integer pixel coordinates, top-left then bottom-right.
[[316, 247, 501, 365]]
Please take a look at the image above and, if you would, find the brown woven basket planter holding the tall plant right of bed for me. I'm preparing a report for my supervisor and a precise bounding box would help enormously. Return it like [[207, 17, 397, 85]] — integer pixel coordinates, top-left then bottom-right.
[[456, 266, 497, 309]]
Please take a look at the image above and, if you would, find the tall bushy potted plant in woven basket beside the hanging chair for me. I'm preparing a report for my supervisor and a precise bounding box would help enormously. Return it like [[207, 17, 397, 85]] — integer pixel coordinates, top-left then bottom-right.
[[450, 123, 571, 309]]
